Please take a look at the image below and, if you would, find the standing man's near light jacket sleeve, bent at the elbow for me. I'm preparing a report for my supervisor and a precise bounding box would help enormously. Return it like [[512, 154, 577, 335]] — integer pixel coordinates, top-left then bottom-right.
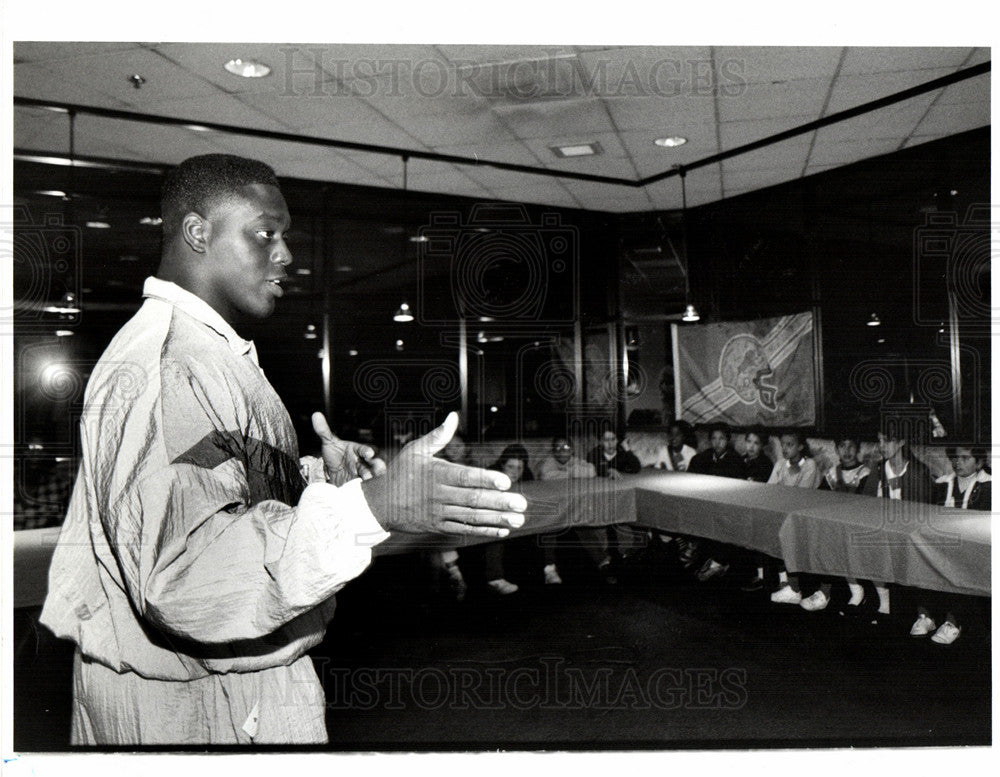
[[90, 354, 388, 643]]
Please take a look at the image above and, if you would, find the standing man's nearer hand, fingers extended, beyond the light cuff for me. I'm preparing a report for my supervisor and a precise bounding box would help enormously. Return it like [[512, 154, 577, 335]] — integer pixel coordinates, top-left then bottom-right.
[[361, 413, 527, 537]]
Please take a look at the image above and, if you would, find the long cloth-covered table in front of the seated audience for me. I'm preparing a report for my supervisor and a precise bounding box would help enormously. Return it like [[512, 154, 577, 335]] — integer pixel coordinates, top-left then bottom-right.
[[14, 471, 992, 607]]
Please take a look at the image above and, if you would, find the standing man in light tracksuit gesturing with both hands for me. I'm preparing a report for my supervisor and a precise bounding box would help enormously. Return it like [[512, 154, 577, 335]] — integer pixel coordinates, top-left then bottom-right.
[[42, 154, 525, 745]]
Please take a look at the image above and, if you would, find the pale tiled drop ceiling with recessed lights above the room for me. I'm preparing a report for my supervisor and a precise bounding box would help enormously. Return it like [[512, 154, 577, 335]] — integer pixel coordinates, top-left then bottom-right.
[[14, 42, 990, 213]]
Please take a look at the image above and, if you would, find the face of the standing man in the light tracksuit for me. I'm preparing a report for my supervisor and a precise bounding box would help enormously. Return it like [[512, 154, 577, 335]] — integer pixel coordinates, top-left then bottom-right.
[[201, 184, 292, 322]]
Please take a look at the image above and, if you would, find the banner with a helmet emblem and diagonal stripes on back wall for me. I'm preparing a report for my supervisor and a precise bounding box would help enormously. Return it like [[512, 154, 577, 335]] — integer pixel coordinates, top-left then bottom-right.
[[672, 313, 819, 426]]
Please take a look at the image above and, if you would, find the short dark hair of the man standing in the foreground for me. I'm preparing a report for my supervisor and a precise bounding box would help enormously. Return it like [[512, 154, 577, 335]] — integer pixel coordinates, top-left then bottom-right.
[[160, 154, 278, 237]]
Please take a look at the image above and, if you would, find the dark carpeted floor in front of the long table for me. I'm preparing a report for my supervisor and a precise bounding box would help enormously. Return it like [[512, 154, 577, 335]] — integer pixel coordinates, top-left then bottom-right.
[[14, 538, 991, 751]]
